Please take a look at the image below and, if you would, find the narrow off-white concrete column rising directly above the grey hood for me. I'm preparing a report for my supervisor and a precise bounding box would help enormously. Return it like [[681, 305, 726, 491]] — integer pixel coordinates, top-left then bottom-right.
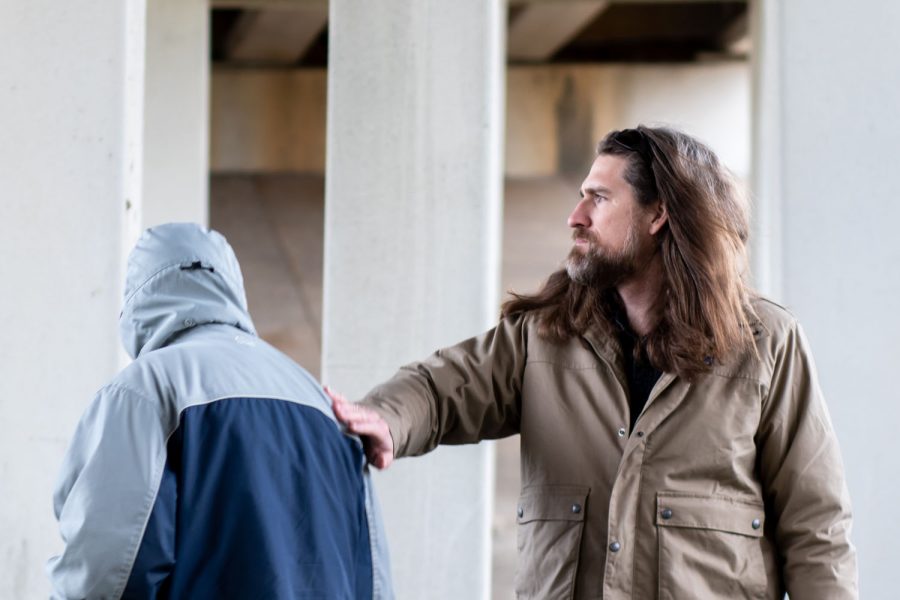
[[143, 0, 209, 227]]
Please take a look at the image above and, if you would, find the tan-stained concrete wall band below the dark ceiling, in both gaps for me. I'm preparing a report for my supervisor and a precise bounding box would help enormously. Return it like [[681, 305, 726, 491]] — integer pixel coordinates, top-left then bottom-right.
[[211, 62, 750, 178]]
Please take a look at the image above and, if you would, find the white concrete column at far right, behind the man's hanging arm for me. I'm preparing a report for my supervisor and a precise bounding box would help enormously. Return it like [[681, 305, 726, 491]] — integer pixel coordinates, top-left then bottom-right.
[[754, 0, 900, 598]]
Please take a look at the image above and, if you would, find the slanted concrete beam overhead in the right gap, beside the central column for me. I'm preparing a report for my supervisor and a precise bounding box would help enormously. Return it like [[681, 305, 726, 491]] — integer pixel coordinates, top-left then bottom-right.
[[507, 0, 610, 62]]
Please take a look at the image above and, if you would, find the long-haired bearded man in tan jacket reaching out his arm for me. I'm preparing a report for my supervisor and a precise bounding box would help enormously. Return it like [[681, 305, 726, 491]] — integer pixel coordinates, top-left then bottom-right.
[[332, 126, 858, 600]]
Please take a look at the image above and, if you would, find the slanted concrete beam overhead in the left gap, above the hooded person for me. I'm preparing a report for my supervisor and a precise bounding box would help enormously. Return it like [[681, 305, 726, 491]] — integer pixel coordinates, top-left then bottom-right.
[[227, 4, 328, 65]]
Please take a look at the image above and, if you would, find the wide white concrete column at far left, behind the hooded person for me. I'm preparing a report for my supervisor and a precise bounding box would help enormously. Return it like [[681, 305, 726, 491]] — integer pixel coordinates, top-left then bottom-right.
[[0, 0, 145, 598]]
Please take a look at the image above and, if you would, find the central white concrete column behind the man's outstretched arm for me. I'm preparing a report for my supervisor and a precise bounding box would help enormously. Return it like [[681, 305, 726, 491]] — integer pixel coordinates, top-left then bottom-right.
[[322, 0, 506, 600]]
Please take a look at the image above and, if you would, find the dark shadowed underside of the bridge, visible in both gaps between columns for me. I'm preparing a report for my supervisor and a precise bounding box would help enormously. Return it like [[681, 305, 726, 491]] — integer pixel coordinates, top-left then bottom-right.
[[211, 0, 750, 68]]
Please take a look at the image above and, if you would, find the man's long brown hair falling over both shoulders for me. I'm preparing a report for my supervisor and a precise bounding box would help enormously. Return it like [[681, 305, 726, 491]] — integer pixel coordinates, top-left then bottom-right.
[[502, 126, 755, 379]]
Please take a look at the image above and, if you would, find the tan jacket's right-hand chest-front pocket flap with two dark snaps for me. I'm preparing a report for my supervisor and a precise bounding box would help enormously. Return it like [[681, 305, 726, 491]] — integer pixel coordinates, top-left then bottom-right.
[[656, 492, 766, 537]]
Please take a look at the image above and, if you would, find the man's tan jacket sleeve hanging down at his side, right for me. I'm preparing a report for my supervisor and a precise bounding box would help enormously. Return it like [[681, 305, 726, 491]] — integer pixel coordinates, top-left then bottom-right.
[[757, 323, 858, 600]]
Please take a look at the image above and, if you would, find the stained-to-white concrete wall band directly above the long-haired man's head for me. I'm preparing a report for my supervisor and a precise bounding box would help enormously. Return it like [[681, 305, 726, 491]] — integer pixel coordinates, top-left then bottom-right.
[[506, 62, 750, 178]]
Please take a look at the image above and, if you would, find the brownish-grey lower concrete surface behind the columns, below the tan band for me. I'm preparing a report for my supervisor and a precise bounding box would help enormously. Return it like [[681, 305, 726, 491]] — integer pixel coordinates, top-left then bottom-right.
[[210, 174, 578, 600]]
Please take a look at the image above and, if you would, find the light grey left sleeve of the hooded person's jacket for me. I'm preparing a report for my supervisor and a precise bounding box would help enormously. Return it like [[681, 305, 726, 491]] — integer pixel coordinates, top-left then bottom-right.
[[47, 387, 171, 599]]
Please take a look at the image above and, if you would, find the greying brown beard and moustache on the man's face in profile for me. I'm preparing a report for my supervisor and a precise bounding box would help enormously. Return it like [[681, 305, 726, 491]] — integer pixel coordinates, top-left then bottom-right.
[[565, 226, 638, 290]]
